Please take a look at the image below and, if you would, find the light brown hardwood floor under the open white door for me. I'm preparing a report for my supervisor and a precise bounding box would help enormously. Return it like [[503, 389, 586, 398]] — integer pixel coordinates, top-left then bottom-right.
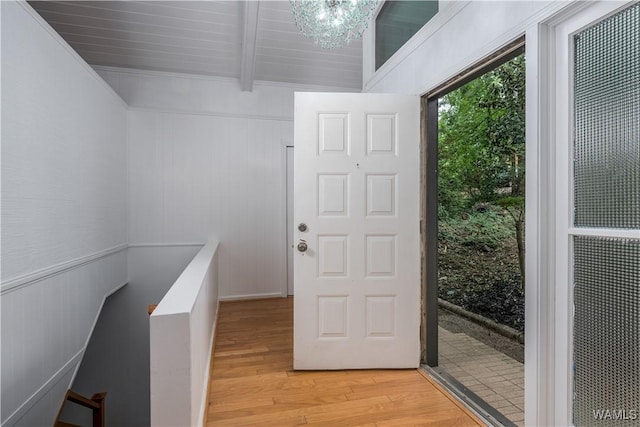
[[205, 298, 483, 426]]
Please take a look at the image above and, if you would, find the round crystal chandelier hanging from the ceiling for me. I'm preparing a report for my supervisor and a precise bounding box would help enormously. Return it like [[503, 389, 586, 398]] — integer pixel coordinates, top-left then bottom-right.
[[289, 0, 379, 49]]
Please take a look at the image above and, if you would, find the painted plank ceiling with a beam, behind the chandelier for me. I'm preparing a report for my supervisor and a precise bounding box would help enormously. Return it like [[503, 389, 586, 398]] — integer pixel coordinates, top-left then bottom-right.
[[29, 0, 362, 91]]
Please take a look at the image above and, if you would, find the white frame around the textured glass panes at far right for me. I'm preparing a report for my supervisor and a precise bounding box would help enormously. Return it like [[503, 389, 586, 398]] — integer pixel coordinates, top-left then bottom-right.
[[549, 2, 638, 425]]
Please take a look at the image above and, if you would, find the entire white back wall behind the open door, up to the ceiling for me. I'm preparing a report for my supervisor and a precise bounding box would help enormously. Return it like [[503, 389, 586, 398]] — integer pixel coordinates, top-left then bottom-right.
[[98, 68, 350, 299]]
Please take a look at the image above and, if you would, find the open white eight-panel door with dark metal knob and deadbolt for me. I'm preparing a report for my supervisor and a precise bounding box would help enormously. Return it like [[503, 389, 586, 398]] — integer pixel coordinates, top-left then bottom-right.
[[294, 93, 420, 369]]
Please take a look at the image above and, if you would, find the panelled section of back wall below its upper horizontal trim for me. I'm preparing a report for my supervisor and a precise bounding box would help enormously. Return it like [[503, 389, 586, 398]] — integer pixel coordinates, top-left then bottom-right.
[[129, 111, 290, 296]]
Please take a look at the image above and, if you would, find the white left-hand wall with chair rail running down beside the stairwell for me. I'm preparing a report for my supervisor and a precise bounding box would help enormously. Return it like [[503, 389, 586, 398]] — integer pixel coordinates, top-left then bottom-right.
[[1, 1, 127, 426]]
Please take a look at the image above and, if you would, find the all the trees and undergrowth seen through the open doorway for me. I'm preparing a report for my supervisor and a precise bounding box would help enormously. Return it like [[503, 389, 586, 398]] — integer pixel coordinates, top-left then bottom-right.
[[438, 55, 525, 329]]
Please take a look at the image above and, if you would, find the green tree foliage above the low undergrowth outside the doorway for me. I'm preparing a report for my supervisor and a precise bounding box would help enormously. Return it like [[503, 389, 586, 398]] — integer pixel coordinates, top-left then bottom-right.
[[438, 55, 525, 285]]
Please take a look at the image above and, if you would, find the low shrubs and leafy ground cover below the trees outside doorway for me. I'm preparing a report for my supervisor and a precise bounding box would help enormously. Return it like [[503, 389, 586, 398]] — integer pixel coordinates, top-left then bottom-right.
[[438, 204, 524, 329]]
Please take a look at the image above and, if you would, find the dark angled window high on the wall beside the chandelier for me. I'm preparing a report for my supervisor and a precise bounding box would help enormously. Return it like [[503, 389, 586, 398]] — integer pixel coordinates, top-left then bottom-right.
[[375, 0, 438, 70]]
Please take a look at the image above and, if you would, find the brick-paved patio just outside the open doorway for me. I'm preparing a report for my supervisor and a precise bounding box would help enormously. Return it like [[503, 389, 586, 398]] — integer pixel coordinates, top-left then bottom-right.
[[438, 327, 524, 426]]
